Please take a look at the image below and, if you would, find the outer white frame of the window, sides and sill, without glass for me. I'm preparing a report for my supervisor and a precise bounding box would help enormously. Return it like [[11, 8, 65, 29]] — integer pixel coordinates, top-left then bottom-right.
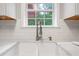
[[21, 3, 59, 27]]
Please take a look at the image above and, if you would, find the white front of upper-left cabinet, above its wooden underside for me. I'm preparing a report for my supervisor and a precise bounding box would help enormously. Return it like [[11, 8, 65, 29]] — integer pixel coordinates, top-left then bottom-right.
[[0, 3, 16, 18]]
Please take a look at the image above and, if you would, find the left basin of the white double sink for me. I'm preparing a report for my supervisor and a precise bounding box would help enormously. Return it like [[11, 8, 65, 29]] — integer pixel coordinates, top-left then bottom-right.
[[19, 42, 36, 56]]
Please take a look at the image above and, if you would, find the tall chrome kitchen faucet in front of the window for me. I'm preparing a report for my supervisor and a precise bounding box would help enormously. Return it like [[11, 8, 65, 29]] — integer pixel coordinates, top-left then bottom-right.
[[36, 20, 42, 41]]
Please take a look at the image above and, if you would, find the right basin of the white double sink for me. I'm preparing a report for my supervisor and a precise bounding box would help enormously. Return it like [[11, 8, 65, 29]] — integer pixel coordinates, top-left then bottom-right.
[[39, 43, 57, 56]]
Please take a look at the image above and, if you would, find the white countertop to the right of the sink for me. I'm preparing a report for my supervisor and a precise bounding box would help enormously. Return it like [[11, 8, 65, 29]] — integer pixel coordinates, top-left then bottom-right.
[[58, 42, 79, 56]]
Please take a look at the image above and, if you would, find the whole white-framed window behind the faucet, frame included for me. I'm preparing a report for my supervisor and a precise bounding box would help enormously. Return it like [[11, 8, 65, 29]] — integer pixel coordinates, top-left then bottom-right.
[[21, 3, 57, 27]]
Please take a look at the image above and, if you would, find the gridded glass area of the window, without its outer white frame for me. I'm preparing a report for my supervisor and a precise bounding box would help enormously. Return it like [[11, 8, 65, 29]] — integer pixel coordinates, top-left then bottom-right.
[[27, 3, 54, 26]]
